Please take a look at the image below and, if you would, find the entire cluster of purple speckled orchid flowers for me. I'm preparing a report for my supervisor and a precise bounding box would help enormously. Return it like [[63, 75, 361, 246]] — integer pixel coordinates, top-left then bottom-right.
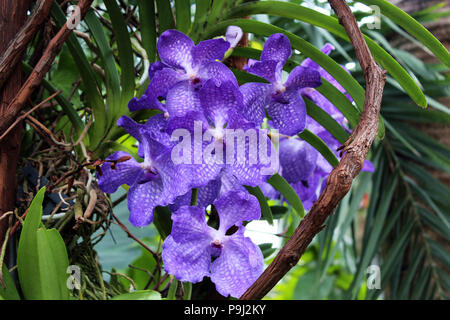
[[98, 27, 370, 297]]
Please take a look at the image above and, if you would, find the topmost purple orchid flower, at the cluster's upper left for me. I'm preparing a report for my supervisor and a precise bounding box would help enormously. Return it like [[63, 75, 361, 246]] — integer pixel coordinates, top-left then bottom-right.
[[128, 30, 237, 117]]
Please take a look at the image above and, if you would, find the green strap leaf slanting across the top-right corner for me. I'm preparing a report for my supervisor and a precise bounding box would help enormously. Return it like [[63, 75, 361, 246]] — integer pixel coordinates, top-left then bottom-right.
[[358, 0, 450, 67]]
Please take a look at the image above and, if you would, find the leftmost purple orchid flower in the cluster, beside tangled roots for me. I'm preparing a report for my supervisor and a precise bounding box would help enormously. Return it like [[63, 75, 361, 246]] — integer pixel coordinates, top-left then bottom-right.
[[98, 115, 219, 227]]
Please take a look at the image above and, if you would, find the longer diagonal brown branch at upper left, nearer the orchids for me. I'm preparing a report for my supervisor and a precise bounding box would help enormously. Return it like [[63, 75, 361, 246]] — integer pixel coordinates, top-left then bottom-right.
[[0, 0, 93, 134]]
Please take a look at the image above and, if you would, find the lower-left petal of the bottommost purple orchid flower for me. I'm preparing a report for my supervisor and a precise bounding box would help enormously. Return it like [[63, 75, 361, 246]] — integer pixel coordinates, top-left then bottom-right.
[[162, 236, 211, 283]]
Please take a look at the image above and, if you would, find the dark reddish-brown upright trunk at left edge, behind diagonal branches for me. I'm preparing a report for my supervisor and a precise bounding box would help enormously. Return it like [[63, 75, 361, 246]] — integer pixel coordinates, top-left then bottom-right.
[[0, 0, 29, 258]]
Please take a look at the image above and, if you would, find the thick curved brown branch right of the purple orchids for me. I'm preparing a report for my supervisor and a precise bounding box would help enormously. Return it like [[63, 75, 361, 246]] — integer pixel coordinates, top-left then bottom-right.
[[241, 0, 385, 300]]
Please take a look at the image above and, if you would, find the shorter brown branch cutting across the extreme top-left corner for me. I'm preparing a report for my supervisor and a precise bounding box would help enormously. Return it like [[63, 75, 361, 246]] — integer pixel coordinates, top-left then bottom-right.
[[0, 0, 53, 88]]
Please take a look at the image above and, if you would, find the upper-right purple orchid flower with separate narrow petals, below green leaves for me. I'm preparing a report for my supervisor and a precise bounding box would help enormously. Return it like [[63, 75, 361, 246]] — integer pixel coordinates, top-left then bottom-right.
[[241, 33, 321, 135]]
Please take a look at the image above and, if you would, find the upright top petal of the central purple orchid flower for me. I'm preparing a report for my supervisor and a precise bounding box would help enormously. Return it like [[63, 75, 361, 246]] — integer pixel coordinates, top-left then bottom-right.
[[199, 79, 243, 127]]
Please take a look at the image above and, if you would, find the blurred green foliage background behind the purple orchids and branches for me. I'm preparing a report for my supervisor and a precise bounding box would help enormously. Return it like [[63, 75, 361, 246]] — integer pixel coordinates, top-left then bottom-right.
[[5, 0, 450, 299]]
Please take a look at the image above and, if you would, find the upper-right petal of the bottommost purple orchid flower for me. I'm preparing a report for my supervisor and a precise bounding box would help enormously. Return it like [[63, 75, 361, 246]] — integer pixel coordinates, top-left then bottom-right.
[[214, 191, 261, 233]]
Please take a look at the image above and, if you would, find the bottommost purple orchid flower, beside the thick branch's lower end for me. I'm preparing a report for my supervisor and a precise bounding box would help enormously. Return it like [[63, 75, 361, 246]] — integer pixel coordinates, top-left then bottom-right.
[[162, 191, 264, 298]]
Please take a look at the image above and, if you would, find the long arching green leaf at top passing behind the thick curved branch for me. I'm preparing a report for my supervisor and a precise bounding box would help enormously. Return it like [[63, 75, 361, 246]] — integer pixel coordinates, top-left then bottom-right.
[[223, 1, 427, 107]]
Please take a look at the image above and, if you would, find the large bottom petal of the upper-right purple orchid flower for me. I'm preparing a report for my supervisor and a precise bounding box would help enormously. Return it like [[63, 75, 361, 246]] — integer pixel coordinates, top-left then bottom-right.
[[267, 90, 306, 136]]
